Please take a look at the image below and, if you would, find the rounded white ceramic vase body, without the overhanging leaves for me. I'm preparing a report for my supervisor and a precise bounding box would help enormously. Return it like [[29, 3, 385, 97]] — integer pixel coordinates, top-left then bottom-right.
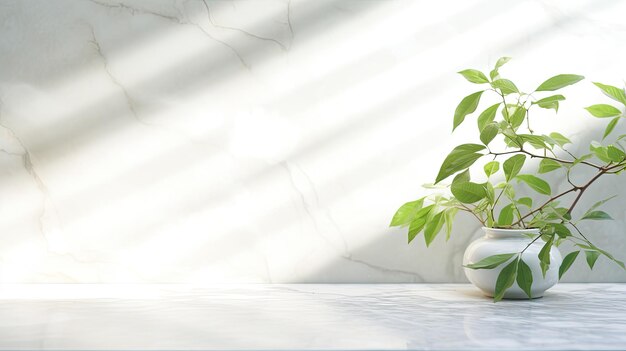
[[463, 227, 563, 299]]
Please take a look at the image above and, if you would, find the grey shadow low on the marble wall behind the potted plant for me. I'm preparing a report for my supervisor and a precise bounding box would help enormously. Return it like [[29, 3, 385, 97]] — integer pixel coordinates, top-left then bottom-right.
[[298, 117, 626, 283]]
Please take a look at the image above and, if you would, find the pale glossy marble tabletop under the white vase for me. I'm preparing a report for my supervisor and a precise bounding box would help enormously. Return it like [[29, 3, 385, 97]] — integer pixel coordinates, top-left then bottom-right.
[[0, 284, 626, 350]]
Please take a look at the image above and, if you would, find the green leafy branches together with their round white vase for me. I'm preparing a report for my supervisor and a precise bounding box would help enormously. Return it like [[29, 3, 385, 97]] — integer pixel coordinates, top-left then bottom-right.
[[390, 57, 626, 301]]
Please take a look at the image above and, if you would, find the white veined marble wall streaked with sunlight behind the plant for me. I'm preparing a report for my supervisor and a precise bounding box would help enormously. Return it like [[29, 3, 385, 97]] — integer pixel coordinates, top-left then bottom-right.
[[0, 0, 626, 283]]
